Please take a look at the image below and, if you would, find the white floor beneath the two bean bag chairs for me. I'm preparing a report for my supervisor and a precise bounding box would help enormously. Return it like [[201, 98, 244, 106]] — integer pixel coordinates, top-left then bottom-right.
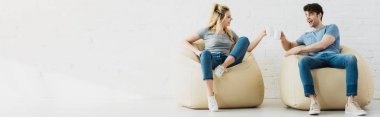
[[0, 99, 380, 117]]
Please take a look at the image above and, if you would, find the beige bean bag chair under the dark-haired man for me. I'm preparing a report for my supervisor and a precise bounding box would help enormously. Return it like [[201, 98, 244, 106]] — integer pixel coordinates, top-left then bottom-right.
[[280, 46, 374, 110]]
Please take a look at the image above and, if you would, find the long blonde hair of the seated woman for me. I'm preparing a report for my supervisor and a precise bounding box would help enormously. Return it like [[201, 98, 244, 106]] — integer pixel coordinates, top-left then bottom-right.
[[208, 4, 235, 43]]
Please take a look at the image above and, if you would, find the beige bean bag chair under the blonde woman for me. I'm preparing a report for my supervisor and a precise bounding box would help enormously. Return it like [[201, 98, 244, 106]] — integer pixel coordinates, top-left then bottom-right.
[[174, 40, 264, 109]]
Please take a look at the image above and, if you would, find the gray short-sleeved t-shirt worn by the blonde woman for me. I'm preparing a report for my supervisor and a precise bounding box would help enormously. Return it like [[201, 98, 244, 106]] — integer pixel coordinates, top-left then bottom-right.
[[198, 28, 239, 55]]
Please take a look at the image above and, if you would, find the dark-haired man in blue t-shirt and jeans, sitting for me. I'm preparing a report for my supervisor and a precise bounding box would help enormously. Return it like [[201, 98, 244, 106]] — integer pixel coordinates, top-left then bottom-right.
[[281, 3, 366, 115]]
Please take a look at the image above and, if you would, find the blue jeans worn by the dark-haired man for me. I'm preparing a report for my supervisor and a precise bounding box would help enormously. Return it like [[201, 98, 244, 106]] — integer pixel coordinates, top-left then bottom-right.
[[298, 53, 358, 97]]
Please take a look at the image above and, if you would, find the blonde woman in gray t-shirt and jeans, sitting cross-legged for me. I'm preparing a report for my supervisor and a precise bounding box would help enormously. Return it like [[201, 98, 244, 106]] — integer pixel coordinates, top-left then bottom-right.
[[184, 4, 266, 111]]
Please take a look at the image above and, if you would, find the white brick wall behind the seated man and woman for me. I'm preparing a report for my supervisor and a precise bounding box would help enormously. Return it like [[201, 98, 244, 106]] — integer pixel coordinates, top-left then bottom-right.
[[0, 0, 380, 99]]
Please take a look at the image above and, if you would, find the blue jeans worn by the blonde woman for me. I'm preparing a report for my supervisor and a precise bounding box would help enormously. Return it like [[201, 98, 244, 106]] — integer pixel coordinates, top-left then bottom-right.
[[200, 37, 249, 80]]
